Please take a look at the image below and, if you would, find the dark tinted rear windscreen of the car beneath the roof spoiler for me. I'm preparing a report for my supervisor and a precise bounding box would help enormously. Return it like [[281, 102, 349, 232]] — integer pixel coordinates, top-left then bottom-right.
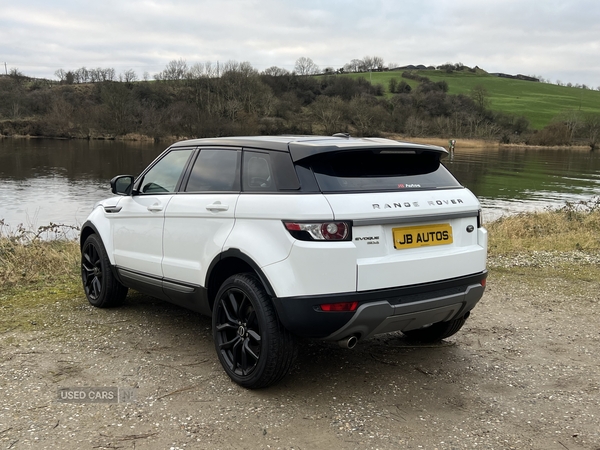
[[301, 150, 461, 192]]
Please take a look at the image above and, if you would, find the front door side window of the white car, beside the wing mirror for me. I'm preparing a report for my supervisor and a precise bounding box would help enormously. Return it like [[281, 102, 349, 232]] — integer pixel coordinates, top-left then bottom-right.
[[139, 149, 193, 194]]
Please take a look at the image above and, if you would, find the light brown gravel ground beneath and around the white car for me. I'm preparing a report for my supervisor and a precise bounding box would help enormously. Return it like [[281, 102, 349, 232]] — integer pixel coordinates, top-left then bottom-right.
[[0, 254, 600, 450]]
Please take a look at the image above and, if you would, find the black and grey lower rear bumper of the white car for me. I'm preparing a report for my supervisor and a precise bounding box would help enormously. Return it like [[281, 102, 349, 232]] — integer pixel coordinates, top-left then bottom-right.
[[273, 271, 487, 341]]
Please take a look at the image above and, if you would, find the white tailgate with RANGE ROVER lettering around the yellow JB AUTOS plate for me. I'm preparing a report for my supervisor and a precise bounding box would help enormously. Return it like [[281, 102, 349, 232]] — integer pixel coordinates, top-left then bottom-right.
[[326, 189, 487, 291]]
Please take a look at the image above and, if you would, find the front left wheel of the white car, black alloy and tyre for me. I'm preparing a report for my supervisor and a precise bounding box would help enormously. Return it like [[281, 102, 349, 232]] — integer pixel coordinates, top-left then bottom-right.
[[81, 234, 127, 308]]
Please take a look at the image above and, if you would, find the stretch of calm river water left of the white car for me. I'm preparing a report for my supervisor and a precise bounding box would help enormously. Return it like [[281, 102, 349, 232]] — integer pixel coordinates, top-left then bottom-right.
[[0, 139, 166, 228]]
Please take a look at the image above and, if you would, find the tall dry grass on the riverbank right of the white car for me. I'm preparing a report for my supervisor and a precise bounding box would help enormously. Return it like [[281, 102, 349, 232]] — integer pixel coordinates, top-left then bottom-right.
[[486, 198, 600, 254]]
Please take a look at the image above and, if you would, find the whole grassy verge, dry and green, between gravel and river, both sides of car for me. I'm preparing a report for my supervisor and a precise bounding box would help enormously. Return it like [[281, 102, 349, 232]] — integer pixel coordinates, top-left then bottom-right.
[[0, 199, 600, 333]]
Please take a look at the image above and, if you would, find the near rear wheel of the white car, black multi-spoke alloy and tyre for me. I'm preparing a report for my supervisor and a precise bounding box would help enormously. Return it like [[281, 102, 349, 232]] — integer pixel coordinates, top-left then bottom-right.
[[213, 274, 297, 389]]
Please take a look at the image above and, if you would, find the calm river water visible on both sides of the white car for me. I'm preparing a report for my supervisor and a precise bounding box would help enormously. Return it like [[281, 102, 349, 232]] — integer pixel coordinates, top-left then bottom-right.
[[0, 139, 600, 229]]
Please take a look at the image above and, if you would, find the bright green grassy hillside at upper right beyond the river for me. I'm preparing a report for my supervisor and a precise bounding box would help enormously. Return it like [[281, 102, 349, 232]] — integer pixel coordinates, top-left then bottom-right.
[[349, 70, 600, 129]]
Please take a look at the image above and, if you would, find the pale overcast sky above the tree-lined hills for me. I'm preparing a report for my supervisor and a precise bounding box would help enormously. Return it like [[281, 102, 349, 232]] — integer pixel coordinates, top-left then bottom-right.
[[0, 0, 600, 88]]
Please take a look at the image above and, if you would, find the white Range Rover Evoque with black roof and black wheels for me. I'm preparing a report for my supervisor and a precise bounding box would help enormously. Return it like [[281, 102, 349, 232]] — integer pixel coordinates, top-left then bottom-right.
[[81, 134, 487, 388]]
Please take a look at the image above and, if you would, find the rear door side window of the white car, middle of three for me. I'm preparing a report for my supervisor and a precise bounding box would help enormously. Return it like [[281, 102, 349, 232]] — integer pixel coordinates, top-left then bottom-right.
[[185, 149, 240, 192]]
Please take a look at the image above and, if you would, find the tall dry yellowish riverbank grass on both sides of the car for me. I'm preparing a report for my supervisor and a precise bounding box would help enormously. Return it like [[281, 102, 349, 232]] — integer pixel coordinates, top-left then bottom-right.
[[0, 198, 600, 294]]
